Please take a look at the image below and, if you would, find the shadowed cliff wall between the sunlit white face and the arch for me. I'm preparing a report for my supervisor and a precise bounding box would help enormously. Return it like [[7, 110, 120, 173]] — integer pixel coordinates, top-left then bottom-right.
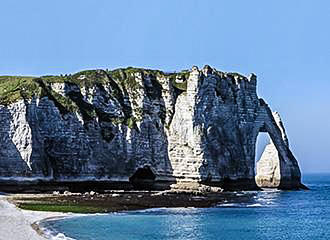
[[194, 69, 259, 190]]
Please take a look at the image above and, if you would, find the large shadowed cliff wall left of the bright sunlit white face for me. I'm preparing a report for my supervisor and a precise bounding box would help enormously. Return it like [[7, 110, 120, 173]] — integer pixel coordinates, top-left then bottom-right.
[[0, 72, 174, 191]]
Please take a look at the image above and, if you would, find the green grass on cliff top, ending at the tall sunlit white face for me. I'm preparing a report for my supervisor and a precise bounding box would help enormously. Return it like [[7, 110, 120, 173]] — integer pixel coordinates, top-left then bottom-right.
[[0, 67, 193, 105]]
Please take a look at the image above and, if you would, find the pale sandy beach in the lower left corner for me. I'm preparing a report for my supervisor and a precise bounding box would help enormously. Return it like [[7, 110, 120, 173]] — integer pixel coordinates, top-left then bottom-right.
[[0, 193, 68, 240]]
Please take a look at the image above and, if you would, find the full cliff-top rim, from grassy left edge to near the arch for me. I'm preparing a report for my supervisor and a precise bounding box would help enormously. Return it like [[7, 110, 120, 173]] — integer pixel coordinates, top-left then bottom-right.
[[0, 65, 250, 105]]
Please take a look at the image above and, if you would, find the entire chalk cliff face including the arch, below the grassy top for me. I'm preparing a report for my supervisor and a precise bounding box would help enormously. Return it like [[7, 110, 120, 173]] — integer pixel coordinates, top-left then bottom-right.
[[0, 66, 300, 189]]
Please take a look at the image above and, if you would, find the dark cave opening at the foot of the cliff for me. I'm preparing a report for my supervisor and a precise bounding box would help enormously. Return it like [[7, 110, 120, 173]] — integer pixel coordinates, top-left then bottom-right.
[[129, 166, 156, 190]]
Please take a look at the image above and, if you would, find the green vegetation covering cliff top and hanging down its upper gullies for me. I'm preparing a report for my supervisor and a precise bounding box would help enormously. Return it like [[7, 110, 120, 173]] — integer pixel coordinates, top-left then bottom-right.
[[0, 67, 189, 136]]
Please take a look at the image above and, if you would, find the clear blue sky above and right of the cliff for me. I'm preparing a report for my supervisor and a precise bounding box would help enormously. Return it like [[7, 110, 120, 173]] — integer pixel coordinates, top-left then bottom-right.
[[0, 0, 330, 172]]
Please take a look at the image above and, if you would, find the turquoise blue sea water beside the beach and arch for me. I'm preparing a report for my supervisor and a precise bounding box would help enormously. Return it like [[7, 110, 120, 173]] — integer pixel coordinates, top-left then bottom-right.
[[46, 174, 330, 240]]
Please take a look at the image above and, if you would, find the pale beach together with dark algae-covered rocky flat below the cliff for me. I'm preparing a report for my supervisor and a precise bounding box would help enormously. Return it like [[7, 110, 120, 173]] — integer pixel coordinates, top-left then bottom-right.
[[0, 190, 300, 240]]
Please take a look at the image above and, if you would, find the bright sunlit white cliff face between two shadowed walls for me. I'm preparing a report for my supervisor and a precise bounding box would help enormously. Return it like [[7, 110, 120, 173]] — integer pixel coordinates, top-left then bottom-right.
[[169, 67, 203, 181]]
